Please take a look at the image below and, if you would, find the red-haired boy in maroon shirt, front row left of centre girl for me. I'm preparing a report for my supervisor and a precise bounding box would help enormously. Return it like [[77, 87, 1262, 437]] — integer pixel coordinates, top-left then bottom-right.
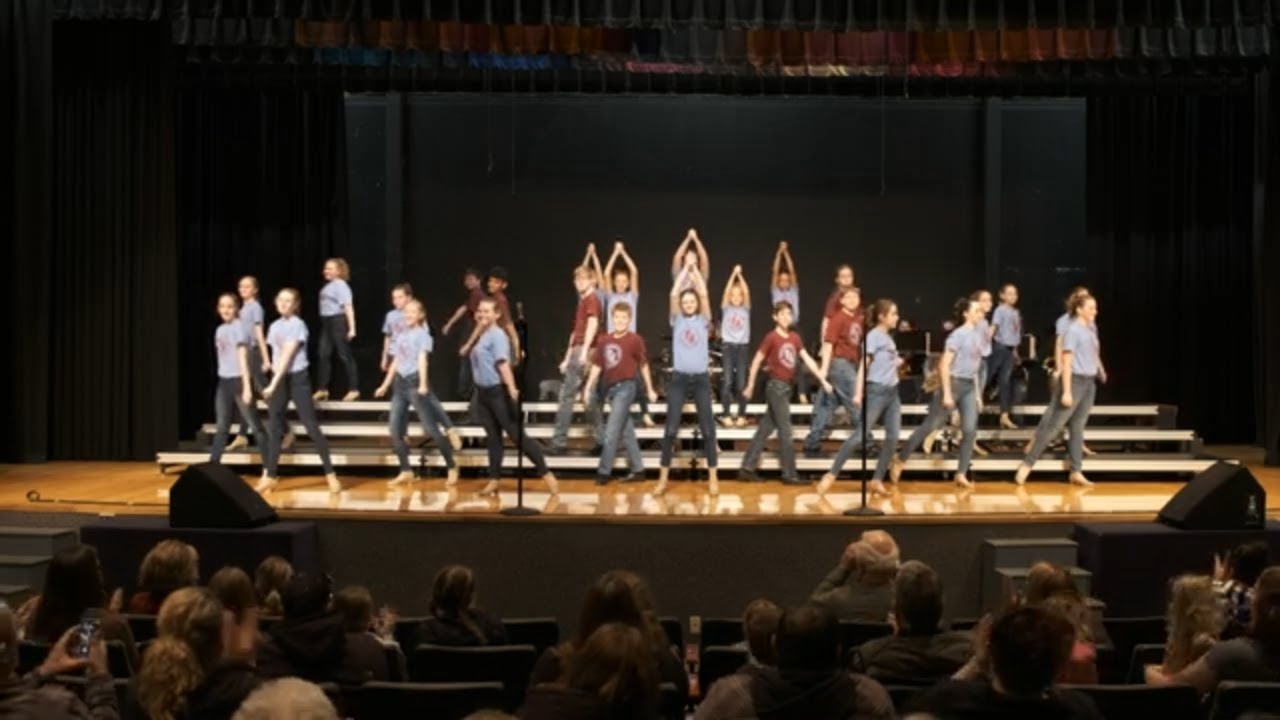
[[582, 302, 658, 486]]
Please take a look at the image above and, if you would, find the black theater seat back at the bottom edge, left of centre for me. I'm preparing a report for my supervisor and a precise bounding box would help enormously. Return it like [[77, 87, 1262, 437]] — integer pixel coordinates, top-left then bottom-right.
[[346, 683, 506, 720]]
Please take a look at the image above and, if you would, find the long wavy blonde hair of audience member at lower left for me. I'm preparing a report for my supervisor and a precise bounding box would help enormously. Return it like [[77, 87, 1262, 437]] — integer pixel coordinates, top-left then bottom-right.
[[137, 588, 223, 720]]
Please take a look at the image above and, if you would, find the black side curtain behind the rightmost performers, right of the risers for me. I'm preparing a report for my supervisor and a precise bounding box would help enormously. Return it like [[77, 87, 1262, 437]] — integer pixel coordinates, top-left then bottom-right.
[[1087, 92, 1256, 442]]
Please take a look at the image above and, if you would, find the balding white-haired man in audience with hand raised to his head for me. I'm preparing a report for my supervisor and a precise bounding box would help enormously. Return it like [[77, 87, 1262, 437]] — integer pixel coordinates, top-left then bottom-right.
[[809, 530, 899, 623]]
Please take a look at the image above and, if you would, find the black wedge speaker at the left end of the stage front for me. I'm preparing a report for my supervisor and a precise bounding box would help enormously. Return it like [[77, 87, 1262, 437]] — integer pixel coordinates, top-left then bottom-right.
[[169, 462, 276, 528]]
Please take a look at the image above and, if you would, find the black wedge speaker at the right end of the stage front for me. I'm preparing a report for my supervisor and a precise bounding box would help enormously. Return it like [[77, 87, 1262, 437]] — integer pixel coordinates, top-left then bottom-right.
[[1160, 461, 1267, 530]]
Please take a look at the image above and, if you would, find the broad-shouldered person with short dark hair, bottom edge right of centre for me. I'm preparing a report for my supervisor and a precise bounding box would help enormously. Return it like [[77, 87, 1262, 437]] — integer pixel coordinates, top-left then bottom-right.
[[695, 603, 895, 720]]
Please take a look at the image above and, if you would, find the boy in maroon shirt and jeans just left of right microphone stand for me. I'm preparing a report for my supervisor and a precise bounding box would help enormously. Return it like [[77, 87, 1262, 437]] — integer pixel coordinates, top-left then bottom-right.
[[804, 285, 865, 457]]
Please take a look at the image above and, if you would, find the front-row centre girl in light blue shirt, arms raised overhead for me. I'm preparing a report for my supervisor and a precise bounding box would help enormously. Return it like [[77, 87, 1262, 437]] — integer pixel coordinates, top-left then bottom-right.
[[653, 256, 719, 496]]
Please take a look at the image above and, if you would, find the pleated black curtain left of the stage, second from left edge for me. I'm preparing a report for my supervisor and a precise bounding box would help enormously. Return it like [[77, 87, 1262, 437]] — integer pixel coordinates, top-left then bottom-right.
[[48, 20, 178, 460]]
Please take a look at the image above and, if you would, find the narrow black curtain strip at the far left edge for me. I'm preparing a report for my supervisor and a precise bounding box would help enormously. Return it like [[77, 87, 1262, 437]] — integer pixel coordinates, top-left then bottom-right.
[[0, 0, 52, 461]]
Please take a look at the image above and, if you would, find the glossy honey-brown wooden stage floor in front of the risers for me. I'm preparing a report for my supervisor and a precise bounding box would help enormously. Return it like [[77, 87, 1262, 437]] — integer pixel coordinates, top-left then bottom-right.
[[0, 447, 1280, 523]]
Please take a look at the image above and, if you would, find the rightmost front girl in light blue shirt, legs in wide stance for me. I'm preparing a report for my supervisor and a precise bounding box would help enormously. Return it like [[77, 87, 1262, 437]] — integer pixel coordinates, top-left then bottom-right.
[[1014, 295, 1107, 487]]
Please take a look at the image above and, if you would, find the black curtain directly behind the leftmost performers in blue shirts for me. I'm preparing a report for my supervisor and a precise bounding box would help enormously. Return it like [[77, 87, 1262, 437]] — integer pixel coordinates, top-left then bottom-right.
[[177, 86, 350, 437]]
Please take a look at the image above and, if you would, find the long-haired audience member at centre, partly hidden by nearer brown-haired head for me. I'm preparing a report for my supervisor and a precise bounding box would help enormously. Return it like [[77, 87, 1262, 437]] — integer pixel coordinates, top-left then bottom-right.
[[529, 570, 689, 701]]
